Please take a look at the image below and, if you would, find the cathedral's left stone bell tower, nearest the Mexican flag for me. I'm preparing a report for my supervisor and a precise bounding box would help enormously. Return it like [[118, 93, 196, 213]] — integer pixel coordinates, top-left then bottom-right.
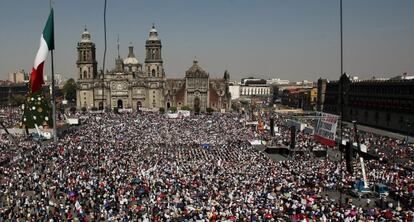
[[76, 27, 98, 81]]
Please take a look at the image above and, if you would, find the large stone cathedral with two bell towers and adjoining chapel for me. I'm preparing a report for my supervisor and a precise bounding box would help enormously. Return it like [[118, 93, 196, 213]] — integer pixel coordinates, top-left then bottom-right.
[[76, 25, 231, 112]]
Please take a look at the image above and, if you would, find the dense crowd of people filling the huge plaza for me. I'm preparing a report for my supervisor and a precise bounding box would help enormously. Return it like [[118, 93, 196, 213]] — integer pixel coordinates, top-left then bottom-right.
[[0, 112, 414, 221]]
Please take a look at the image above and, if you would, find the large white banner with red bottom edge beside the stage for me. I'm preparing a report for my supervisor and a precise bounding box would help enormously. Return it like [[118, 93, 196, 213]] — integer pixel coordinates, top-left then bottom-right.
[[314, 113, 338, 146]]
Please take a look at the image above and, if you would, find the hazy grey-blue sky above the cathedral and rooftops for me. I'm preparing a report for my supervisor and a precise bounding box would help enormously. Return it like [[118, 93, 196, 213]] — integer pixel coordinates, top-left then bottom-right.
[[0, 0, 414, 81]]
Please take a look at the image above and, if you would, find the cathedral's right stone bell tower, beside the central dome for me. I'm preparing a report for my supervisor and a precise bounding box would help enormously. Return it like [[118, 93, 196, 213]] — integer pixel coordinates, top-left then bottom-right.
[[145, 25, 165, 78]]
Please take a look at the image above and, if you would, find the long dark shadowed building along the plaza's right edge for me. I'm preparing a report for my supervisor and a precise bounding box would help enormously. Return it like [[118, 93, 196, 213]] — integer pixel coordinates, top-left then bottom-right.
[[317, 74, 414, 135]]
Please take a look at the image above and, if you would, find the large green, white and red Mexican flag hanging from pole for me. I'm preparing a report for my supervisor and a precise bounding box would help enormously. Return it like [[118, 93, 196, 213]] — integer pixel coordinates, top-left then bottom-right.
[[30, 9, 55, 93]]
